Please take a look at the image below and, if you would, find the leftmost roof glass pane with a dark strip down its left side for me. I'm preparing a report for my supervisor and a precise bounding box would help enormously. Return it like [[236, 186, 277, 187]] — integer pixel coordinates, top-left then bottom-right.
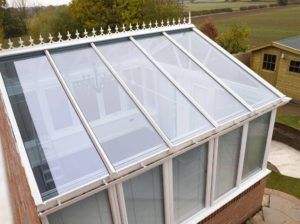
[[0, 56, 107, 200]]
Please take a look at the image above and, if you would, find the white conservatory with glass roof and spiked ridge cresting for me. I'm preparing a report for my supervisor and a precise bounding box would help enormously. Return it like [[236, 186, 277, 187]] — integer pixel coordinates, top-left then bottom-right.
[[0, 16, 289, 224]]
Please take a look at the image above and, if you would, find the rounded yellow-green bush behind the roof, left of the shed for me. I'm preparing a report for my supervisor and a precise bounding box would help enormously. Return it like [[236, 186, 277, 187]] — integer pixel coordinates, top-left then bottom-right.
[[216, 24, 250, 54]]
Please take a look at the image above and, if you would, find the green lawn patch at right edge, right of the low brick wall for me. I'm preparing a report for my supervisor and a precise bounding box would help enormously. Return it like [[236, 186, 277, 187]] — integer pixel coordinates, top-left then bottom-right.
[[267, 172, 300, 198]]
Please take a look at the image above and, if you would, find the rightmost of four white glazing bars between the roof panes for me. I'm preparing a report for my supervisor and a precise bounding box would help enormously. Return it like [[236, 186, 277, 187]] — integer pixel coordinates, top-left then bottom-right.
[[163, 32, 254, 112]]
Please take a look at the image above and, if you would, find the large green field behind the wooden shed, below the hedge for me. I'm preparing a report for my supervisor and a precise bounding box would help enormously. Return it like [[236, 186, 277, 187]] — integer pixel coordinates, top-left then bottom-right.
[[215, 6, 300, 48]]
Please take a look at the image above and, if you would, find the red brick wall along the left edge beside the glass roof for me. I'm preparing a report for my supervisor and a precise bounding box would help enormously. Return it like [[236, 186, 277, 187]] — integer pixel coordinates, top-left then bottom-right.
[[0, 96, 40, 224]]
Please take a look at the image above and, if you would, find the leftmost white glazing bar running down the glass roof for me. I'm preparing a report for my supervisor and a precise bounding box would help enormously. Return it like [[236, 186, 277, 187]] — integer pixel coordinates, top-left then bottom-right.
[[45, 50, 116, 176]]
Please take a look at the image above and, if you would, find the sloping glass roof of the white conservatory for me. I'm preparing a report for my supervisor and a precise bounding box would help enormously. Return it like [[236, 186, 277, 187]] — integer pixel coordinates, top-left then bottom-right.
[[0, 28, 279, 200]]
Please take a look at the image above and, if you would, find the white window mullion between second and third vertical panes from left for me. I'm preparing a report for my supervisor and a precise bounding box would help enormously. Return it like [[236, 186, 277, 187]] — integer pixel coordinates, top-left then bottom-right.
[[163, 159, 174, 224]]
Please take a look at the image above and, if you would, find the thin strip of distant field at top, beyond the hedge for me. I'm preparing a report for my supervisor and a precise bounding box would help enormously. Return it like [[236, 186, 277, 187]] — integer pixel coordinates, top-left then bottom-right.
[[185, 1, 276, 11]]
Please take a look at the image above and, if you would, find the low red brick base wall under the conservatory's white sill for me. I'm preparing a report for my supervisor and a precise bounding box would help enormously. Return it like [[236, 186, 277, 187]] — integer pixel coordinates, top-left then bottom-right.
[[200, 179, 266, 224]]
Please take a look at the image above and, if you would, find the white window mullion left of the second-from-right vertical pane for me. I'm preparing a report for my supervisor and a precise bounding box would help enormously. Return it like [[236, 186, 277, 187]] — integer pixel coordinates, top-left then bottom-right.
[[205, 139, 214, 208]]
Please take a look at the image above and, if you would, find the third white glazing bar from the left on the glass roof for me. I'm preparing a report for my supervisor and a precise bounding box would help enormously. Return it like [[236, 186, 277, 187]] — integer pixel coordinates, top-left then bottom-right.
[[129, 37, 219, 128]]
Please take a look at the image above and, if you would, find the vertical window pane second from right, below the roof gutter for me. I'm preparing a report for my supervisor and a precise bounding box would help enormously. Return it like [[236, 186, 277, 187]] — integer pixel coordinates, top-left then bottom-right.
[[215, 127, 243, 199]]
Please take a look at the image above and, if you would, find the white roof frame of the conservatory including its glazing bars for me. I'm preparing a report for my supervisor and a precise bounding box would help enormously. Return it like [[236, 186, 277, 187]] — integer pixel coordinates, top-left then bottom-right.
[[0, 16, 290, 216]]
